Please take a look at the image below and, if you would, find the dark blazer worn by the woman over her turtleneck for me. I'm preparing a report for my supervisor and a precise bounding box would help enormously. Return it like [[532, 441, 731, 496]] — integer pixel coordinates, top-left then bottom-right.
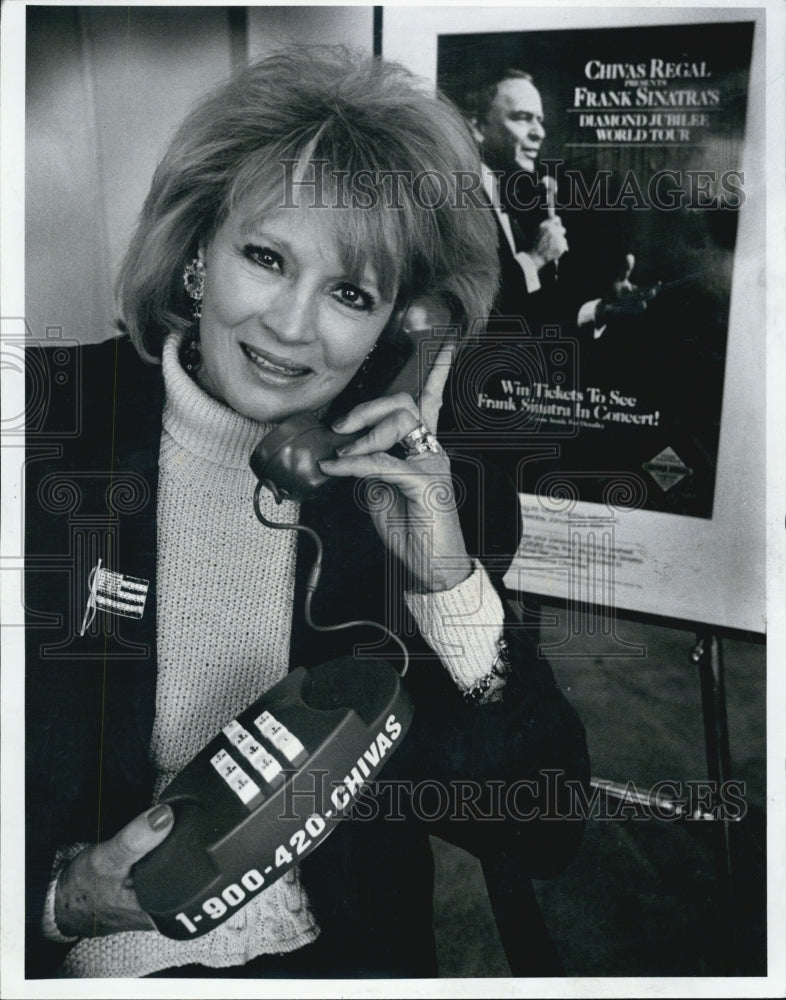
[[25, 338, 588, 976]]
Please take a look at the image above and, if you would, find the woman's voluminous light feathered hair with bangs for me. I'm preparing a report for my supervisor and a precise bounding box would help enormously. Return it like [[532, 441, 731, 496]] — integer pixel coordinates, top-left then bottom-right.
[[117, 46, 498, 359]]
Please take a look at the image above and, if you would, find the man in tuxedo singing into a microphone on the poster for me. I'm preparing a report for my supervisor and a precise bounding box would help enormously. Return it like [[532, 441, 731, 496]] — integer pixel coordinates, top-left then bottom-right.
[[468, 69, 656, 339]]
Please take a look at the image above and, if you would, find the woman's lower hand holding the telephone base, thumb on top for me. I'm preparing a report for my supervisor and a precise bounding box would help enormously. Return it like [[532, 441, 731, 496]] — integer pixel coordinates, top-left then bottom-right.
[[55, 805, 174, 937]]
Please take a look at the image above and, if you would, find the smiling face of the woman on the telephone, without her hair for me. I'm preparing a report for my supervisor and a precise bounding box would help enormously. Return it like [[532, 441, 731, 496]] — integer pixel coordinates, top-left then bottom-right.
[[197, 207, 393, 422]]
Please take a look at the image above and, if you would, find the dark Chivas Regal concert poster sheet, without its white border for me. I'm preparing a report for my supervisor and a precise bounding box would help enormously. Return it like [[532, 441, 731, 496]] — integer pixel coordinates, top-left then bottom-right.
[[437, 21, 753, 518]]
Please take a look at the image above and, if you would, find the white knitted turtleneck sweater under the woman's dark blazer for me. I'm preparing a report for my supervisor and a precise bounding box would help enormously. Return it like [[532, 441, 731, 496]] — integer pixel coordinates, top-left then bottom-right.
[[50, 336, 502, 977]]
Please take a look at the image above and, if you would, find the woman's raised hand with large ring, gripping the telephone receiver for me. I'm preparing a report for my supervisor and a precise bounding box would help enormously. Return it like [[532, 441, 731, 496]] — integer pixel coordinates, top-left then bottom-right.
[[319, 344, 472, 592]]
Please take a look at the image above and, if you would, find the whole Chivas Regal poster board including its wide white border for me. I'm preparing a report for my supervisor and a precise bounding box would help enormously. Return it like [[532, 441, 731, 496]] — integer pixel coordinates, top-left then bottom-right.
[[383, 5, 764, 632]]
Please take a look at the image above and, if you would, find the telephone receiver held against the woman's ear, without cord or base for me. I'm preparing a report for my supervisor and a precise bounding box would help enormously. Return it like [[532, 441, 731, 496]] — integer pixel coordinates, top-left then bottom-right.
[[249, 296, 450, 503]]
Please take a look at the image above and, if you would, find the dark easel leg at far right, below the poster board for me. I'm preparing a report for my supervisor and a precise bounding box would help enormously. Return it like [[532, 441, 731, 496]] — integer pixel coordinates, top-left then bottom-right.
[[690, 632, 738, 975]]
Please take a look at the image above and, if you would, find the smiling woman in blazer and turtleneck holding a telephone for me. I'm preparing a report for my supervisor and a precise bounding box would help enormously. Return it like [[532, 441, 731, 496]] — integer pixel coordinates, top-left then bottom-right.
[[27, 50, 586, 976]]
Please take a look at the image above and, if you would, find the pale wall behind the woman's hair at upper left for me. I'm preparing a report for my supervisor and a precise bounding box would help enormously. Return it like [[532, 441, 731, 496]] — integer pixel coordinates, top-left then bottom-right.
[[25, 6, 372, 342]]
